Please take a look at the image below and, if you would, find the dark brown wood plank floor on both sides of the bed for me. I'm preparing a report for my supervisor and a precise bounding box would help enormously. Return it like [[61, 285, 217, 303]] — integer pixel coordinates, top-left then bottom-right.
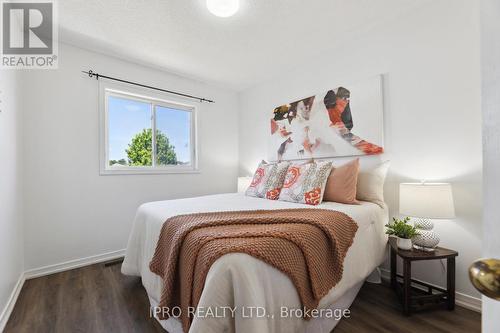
[[4, 264, 481, 333]]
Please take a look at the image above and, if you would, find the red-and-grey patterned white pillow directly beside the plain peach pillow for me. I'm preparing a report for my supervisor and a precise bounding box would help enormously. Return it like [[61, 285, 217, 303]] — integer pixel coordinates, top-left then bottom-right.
[[279, 162, 332, 206]]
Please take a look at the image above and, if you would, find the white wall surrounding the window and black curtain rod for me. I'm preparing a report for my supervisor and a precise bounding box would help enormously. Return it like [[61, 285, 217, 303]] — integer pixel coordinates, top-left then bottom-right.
[[23, 45, 238, 269]]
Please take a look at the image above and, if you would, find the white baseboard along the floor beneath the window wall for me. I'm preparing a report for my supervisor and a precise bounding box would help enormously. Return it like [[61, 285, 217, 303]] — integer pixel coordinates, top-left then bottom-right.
[[24, 249, 125, 280]]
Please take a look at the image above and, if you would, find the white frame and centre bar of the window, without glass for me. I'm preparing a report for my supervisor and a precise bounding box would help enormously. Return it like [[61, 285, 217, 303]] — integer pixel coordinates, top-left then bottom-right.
[[99, 80, 199, 175]]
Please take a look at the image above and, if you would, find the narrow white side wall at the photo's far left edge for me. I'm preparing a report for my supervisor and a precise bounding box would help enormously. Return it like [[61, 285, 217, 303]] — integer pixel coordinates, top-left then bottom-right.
[[0, 70, 24, 331]]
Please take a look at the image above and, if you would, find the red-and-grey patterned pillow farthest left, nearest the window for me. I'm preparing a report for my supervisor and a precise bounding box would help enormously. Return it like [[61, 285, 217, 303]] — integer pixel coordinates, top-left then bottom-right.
[[245, 161, 290, 200]]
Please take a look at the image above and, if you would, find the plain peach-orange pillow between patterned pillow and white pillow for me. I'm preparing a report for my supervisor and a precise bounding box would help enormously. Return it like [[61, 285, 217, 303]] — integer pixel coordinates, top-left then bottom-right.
[[323, 158, 359, 205]]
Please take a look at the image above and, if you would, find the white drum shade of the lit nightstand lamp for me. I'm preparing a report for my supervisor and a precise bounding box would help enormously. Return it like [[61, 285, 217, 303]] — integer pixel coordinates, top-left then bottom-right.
[[399, 183, 455, 219]]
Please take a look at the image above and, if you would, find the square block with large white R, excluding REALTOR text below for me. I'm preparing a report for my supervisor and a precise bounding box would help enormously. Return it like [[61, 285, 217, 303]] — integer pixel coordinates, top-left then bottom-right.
[[2, 2, 54, 54]]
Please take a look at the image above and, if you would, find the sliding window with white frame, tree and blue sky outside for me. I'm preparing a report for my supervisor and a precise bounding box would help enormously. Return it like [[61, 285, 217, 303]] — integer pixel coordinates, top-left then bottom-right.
[[100, 82, 197, 174]]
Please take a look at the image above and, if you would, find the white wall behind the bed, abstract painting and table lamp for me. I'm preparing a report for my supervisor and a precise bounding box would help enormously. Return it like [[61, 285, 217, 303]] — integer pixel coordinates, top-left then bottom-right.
[[239, 0, 481, 297]]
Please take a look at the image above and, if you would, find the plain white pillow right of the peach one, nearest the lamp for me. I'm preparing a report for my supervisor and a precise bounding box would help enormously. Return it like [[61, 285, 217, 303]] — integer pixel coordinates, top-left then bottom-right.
[[356, 161, 391, 206]]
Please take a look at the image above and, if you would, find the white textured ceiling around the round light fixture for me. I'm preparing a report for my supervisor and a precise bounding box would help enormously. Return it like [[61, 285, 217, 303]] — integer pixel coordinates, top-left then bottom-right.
[[58, 0, 426, 91]]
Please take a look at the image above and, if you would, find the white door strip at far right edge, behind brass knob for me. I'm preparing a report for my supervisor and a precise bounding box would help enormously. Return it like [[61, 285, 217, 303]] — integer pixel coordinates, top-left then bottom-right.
[[481, 0, 500, 333]]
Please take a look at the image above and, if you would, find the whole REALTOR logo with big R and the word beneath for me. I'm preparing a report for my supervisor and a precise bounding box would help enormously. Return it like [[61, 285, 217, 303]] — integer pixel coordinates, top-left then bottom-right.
[[0, 0, 57, 69]]
